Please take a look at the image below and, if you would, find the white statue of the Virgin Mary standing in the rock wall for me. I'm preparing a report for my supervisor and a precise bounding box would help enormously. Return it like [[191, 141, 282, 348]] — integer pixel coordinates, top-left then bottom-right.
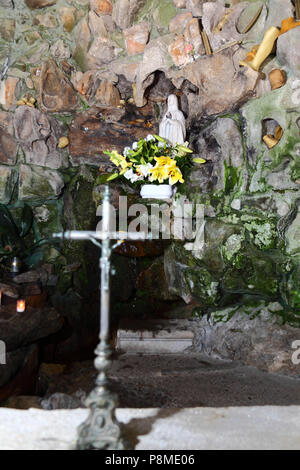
[[159, 95, 186, 145]]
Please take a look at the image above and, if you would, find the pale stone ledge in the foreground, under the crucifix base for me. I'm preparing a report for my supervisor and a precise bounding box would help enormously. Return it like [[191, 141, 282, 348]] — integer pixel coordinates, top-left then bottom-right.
[[0, 406, 300, 450]]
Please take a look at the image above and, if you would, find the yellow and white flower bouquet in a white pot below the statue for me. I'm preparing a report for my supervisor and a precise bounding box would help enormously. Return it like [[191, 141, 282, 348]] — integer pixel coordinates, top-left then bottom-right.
[[104, 134, 205, 197]]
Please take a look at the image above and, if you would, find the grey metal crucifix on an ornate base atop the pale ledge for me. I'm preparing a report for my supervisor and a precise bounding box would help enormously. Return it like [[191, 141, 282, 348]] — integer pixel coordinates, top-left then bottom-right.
[[54, 186, 147, 450]]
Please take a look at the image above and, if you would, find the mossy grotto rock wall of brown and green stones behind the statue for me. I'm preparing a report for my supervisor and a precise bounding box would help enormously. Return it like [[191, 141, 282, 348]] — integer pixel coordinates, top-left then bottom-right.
[[0, 0, 300, 368]]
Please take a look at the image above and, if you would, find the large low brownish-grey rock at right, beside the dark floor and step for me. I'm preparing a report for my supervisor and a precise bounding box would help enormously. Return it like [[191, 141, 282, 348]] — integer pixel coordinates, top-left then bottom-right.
[[193, 303, 300, 377]]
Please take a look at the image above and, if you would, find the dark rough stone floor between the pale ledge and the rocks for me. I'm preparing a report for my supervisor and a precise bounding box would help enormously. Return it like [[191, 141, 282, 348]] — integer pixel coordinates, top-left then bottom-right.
[[29, 352, 300, 408]]
